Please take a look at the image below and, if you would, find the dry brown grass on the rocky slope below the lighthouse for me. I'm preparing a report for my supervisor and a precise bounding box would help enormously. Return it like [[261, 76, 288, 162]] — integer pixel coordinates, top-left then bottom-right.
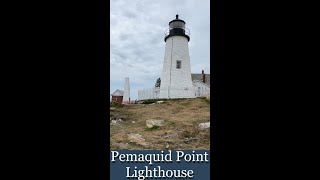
[[110, 98, 210, 150]]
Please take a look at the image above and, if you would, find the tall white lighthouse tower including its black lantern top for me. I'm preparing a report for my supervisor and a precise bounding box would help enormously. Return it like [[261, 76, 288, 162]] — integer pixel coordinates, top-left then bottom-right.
[[160, 14, 195, 99]]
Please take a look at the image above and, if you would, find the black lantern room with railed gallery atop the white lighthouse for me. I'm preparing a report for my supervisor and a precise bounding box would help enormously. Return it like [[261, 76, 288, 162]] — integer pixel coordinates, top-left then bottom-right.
[[164, 14, 190, 41]]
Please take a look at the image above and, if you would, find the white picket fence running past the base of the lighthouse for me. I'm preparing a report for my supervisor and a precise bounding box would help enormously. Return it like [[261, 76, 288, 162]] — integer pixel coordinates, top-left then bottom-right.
[[138, 87, 210, 100]]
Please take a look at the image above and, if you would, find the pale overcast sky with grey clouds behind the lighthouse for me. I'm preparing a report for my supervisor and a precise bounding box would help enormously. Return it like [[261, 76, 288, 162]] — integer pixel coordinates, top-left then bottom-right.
[[110, 0, 210, 100]]
